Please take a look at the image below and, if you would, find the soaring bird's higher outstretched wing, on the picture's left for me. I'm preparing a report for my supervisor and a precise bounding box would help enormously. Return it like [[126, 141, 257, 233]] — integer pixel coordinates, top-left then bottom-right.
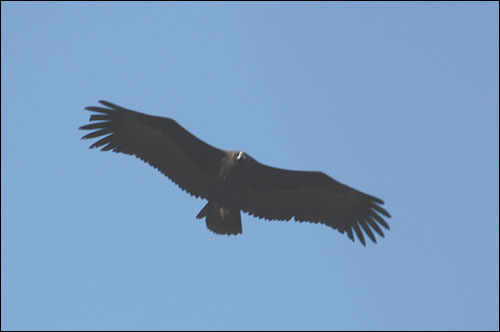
[[80, 101, 224, 199]]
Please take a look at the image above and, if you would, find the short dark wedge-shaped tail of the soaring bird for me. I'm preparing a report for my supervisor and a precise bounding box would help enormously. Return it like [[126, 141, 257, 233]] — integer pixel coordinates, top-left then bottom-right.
[[196, 202, 242, 235]]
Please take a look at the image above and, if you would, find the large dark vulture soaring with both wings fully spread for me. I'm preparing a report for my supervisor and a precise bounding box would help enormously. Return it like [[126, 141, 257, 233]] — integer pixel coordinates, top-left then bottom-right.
[[80, 101, 390, 245]]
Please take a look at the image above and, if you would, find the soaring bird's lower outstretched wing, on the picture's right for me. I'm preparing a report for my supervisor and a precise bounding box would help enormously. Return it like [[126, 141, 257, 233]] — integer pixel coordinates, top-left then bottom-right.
[[240, 159, 390, 245]]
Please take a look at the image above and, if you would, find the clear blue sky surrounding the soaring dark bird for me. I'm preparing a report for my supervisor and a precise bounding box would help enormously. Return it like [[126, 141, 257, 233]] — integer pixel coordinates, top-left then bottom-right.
[[1, 2, 499, 330]]
